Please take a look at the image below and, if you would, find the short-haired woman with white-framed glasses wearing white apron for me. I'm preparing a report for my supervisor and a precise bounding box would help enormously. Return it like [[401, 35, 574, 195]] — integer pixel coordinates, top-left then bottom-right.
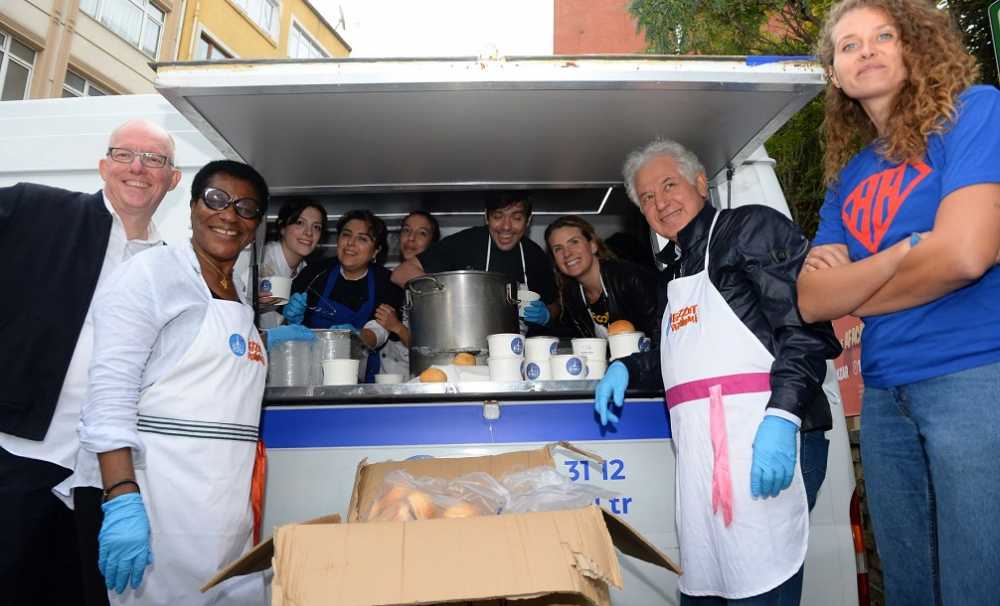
[[80, 160, 268, 606]]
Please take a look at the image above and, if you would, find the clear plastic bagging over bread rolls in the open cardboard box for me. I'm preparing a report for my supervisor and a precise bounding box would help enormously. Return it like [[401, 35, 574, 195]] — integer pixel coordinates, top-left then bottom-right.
[[362, 466, 620, 522]]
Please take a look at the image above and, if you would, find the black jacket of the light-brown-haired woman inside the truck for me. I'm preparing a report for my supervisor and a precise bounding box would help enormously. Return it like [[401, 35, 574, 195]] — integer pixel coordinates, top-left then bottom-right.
[[559, 260, 663, 345]]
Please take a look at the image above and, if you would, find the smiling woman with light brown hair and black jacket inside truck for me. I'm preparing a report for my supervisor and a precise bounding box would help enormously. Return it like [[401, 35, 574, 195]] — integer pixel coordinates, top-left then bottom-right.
[[545, 215, 660, 342]]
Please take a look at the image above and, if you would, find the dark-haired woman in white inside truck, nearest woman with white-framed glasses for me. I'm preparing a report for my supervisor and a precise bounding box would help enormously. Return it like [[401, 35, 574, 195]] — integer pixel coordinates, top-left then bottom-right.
[[257, 200, 327, 328]]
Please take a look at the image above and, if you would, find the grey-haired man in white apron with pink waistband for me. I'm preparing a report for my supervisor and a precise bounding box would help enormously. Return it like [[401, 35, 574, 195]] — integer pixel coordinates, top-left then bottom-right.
[[594, 140, 840, 606]]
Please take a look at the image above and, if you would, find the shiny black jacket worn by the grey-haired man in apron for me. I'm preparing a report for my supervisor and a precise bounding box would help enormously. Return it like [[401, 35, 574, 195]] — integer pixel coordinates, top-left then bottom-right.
[[623, 204, 841, 431]]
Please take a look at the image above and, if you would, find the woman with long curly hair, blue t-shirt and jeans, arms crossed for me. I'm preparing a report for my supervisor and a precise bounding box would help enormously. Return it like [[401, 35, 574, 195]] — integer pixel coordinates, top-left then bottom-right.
[[798, 0, 1000, 605]]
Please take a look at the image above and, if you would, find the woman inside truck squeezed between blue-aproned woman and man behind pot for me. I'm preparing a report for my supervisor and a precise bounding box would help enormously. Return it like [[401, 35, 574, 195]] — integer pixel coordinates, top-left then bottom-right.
[[375, 210, 441, 378]]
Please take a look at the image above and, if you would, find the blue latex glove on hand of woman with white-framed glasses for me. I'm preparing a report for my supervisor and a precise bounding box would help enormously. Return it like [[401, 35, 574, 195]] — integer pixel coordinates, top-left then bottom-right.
[[97, 492, 153, 593]]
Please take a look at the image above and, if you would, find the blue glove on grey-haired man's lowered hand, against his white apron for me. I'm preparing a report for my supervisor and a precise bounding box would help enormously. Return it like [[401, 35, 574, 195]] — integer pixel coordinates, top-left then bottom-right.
[[750, 415, 799, 498]]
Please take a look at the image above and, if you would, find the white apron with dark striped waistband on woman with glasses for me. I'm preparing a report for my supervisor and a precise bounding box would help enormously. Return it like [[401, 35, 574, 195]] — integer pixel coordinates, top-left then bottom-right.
[[108, 298, 267, 606]]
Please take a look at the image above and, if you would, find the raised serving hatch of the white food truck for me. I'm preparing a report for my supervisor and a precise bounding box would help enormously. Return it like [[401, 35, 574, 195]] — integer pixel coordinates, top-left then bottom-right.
[[150, 55, 824, 213]]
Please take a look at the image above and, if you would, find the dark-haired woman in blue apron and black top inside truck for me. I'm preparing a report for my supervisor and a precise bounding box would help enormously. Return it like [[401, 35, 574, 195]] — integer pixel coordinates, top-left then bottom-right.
[[284, 210, 403, 382]]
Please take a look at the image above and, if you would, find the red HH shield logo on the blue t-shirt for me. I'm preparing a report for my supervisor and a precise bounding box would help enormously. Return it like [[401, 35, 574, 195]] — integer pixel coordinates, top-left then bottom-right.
[[841, 162, 931, 254]]
